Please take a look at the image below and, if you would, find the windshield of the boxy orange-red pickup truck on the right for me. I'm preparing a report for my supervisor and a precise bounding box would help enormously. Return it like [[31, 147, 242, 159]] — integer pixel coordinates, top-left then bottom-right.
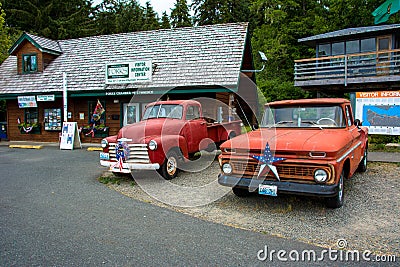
[[261, 106, 346, 129]]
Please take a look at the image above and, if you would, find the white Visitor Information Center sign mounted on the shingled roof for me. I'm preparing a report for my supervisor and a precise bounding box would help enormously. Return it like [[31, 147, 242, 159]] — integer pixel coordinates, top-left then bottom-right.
[[106, 60, 153, 84]]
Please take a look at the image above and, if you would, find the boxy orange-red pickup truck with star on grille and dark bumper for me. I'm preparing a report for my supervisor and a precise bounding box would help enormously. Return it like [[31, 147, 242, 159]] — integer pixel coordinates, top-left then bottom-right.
[[218, 98, 368, 208]]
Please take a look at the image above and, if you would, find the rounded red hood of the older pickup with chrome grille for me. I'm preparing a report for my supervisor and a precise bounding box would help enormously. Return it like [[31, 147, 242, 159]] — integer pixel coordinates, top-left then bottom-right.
[[117, 118, 184, 143]]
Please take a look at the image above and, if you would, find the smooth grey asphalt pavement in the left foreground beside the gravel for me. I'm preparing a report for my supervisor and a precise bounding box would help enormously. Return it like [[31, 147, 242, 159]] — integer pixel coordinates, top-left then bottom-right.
[[0, 146, 378, 266]]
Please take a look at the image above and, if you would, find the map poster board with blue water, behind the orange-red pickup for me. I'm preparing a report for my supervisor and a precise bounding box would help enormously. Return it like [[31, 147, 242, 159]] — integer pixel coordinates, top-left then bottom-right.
[[355, 91, 400, 135]]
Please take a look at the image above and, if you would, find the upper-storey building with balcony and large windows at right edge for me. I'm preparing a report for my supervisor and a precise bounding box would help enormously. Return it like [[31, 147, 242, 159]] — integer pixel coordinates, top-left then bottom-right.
[[294, 24, 400, 94]]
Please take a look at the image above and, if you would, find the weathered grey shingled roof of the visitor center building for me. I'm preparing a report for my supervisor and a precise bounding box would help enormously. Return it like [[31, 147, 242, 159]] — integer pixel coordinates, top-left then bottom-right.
[[0, 23, 248, 95]]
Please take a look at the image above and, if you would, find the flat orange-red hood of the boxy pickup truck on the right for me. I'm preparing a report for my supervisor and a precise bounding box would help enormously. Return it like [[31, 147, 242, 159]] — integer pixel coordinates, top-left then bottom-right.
[[221, 128, 352, 154]]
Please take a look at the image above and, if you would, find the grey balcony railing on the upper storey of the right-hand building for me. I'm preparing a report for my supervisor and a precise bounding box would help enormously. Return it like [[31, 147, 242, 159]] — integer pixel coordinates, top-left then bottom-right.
[[295, 49, 400, 86]]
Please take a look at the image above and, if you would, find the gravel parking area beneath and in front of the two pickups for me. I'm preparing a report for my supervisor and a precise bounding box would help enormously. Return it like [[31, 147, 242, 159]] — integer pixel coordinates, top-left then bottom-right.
[[104, 162, 400, 256]]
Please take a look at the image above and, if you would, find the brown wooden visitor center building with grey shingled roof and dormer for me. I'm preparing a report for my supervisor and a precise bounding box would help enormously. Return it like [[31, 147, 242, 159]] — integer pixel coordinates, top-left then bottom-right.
[[0, 23, 258, 142]]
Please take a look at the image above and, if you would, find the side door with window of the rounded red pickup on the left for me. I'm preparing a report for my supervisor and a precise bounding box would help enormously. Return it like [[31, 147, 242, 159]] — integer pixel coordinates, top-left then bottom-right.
[[186, 106, 208, 153]]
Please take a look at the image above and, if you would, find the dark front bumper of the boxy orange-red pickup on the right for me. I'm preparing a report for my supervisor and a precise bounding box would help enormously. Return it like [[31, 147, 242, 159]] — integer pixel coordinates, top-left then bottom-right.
[[218, 174, 338, 197]]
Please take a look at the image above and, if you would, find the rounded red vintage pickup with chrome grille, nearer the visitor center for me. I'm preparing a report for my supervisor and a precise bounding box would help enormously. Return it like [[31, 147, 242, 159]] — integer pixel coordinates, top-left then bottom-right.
[[100, 100, 241, 179]]
